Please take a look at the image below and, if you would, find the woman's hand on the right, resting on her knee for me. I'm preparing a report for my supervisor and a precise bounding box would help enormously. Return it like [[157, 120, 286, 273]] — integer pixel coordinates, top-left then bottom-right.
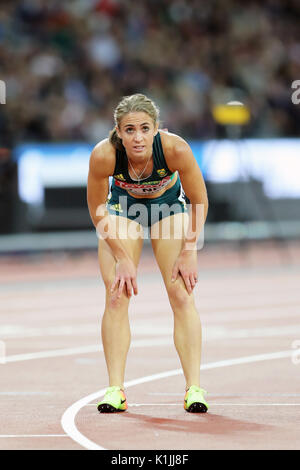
[[171, 250, 198, 294]]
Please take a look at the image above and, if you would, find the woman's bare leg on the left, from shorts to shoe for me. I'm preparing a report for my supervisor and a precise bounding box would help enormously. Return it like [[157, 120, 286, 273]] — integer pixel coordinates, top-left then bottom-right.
[[98, 215, 143, 388]]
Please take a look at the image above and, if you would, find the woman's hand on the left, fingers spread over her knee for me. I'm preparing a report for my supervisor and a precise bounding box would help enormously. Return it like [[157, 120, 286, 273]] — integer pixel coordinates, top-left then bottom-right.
[[111, 257, 138, 298]]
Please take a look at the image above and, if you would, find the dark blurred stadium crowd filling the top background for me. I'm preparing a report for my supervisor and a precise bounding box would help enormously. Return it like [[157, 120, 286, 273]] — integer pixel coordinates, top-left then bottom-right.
[[0, 0, 300, 146]]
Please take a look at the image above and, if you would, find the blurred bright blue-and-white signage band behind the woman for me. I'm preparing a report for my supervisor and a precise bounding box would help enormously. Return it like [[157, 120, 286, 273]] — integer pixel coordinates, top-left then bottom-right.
[[14, 139, 300, 205]]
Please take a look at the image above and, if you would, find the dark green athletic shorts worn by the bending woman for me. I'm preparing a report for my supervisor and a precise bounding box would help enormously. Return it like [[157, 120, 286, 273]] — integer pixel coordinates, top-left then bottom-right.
[[106, 178, 190, 227]]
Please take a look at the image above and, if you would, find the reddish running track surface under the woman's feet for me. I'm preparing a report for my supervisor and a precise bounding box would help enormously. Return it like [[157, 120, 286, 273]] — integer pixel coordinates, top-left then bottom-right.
[[0, 242, 300, 450]]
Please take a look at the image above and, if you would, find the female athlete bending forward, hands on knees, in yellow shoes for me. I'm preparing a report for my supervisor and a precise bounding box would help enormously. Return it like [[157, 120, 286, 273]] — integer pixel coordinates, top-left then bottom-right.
[[87, 93, 208, 413]]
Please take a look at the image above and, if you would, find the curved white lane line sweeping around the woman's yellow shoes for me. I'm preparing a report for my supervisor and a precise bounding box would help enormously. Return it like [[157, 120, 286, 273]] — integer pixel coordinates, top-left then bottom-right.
[[61, 349, 293, 450]]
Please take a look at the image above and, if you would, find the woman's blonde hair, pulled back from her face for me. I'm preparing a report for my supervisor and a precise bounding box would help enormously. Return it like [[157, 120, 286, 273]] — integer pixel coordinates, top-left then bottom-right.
[[109, 93, 159, 150]]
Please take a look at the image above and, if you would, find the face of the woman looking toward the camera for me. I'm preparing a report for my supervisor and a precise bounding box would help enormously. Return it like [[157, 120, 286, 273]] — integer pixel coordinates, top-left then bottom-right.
[[117, 112, 158, 161]]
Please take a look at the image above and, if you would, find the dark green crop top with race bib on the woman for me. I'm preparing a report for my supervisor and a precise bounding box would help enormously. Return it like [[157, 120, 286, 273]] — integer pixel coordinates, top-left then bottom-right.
[[111, 132, 176, 196]]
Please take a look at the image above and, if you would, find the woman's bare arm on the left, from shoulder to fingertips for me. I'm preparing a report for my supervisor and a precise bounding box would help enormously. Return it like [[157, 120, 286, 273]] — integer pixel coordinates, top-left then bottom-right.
[[87, 140, 137, 297]]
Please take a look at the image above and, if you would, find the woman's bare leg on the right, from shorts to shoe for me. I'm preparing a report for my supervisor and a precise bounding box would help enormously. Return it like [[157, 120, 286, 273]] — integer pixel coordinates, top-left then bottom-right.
[[151, 213, 202, 388]]
